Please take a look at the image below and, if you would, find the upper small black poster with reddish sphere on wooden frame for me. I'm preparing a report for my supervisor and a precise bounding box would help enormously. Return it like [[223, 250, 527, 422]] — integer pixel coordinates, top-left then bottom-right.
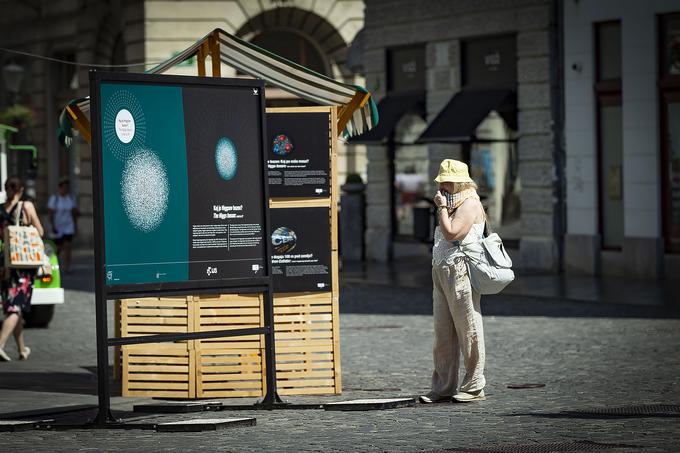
[[265, 112, 330, 198]]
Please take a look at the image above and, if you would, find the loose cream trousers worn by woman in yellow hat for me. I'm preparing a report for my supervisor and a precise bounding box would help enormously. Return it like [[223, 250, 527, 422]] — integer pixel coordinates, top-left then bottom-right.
[[431, 257, 486, 397]]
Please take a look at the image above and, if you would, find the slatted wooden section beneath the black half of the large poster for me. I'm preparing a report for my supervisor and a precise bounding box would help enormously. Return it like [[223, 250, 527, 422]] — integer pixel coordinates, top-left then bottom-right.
[[193, 294, 265, 398]]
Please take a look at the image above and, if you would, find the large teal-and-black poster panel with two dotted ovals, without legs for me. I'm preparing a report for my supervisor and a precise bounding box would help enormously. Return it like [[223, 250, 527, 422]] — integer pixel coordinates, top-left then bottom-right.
[[93, 73, 268, 294]]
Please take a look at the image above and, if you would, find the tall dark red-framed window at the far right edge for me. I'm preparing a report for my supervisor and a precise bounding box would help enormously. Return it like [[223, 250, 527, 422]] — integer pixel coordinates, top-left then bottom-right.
[[659, 13, 680, 253]]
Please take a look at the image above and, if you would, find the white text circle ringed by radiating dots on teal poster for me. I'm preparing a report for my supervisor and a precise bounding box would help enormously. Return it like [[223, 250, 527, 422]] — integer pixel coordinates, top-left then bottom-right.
[[102, 90, 146, 161]]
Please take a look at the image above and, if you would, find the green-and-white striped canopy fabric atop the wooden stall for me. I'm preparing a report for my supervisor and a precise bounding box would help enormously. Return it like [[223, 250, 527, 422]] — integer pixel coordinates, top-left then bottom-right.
[[59, 28, 378, 141]]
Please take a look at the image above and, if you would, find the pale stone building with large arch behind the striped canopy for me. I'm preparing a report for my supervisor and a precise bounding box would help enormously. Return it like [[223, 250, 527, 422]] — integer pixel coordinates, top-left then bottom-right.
[[0, 0, 366, 246]]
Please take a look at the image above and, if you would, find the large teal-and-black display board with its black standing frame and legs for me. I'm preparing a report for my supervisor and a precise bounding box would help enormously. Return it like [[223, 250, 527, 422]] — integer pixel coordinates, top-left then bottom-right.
[[90, 71, 277, 424]]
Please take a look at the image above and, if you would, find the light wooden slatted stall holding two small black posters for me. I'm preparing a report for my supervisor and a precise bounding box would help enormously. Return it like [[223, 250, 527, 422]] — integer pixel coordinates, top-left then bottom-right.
[[116, 107, 342, 398]]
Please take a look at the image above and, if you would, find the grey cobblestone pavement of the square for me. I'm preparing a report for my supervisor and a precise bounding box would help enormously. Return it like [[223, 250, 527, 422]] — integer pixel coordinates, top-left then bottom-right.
[[0, 256, 680, 452]]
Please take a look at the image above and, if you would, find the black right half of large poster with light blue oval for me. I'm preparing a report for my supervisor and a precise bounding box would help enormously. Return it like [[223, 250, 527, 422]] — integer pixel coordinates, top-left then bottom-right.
[[184, 87, 266, 280]]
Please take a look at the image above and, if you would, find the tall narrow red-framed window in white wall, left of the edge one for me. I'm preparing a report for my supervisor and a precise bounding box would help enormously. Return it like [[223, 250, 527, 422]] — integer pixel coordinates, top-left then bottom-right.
[[595, 21, 623, 249]]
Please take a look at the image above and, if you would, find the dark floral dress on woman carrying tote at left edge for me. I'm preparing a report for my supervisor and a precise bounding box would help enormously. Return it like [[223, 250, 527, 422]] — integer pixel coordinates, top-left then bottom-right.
[[0, 203, 36, 315]]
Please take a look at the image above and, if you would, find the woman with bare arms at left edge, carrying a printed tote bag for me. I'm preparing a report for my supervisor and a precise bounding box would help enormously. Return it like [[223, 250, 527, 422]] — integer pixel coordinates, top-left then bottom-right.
[[0, 177, 44, 362]]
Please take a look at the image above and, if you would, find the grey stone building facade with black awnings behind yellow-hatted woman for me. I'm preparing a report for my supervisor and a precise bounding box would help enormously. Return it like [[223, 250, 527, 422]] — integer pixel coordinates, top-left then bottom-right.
[[357, 0, 564, 271]]
